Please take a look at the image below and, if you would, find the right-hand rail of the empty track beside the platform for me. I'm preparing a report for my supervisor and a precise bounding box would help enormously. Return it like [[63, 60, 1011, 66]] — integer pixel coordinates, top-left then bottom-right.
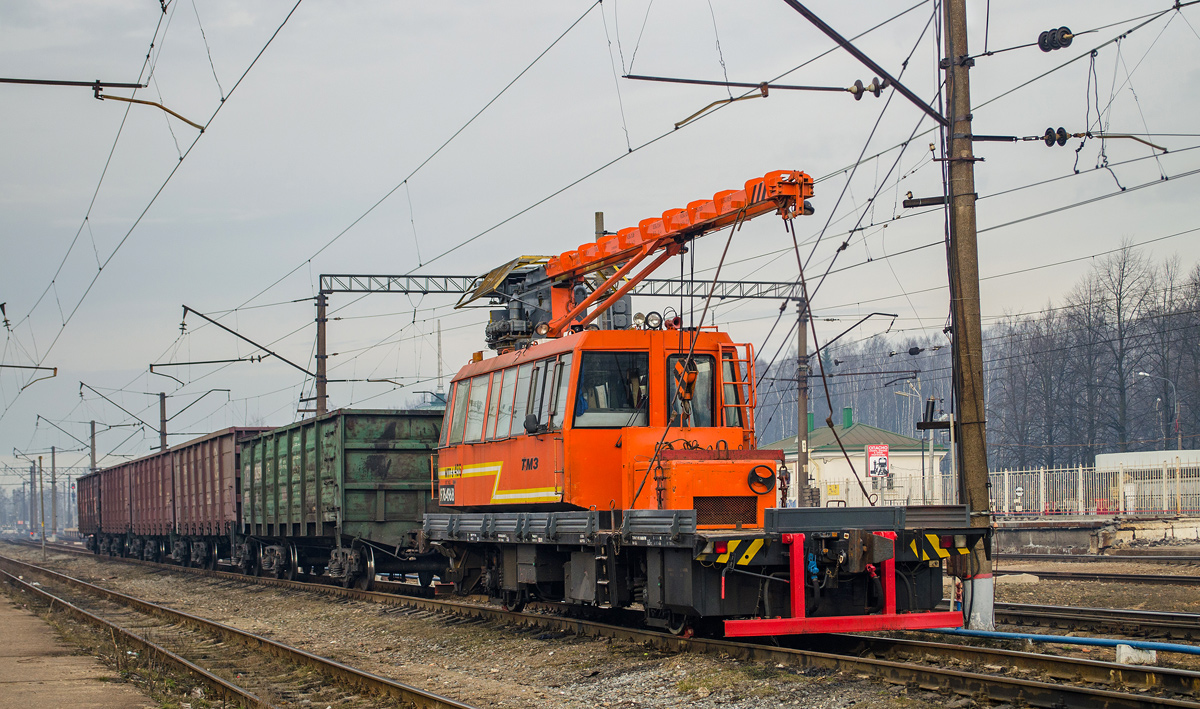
[[0, 555, 473, 709]]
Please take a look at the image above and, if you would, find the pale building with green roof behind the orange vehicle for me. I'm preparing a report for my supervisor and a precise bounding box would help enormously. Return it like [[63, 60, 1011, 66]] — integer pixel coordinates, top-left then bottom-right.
[[758, 407, 958, 506]]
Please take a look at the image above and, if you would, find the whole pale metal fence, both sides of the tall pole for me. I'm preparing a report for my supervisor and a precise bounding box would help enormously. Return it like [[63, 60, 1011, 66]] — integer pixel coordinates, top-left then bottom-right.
[[816, 461, 1200, 517]]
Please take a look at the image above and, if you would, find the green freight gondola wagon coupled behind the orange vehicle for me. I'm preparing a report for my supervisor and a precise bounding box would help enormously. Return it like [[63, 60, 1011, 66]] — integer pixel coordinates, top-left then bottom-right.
[[233, 409, 445, 588]]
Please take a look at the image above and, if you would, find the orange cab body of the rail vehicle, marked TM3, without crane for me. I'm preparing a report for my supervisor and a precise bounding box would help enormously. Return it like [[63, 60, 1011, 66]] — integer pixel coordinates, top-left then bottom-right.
[[437, 329, 781, 529]]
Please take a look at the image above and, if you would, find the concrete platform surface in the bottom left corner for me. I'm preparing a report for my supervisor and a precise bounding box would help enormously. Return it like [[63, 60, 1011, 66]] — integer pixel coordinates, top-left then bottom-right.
[[0, 595, 157, 709]]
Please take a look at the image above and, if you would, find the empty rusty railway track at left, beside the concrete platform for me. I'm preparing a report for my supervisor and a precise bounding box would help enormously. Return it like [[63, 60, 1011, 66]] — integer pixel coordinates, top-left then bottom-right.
[[0, 557, 470, 709]]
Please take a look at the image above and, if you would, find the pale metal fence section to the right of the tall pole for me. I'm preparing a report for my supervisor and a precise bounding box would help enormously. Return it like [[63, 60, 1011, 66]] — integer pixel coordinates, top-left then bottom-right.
[[990, 461, 1200, 516]]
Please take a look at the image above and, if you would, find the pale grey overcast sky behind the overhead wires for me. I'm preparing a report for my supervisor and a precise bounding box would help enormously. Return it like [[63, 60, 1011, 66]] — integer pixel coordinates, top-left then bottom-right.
[[0, 0, 1200, 485]]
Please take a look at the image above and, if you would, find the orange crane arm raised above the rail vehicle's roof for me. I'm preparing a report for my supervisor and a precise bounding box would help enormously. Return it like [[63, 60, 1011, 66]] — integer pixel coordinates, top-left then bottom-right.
[[546, 170, 812, 337]]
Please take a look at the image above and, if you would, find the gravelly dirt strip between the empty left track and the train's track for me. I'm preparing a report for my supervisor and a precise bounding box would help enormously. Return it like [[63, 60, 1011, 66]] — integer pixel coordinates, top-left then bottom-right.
[[0, 543, 955, 709]]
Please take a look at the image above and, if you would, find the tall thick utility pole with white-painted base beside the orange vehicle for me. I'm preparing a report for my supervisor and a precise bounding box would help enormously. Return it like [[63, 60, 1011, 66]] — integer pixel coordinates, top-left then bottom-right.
[[943, 0, 995, 630]]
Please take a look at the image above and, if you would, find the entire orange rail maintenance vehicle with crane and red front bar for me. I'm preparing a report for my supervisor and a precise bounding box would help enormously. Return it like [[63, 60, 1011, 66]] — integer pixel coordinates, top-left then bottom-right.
[[421, 170, 990, 636]]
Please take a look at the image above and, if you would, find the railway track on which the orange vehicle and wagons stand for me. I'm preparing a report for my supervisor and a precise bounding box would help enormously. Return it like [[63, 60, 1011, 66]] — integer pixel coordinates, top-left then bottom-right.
[[9, 539, 1200, 709]]
